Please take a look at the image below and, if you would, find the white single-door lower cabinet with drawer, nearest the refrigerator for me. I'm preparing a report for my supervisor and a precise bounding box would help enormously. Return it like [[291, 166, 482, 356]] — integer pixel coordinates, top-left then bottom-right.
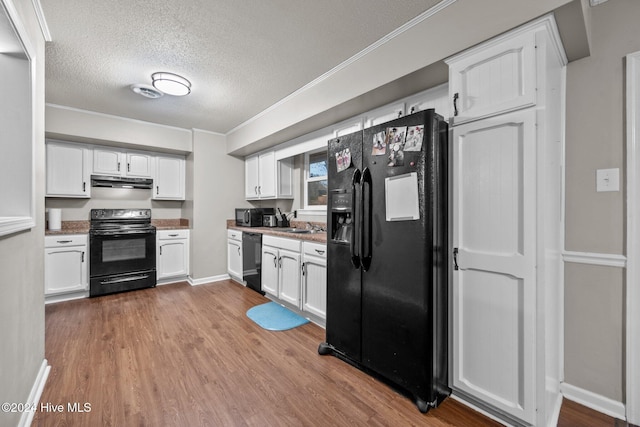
[[302, 242, 327, 320]]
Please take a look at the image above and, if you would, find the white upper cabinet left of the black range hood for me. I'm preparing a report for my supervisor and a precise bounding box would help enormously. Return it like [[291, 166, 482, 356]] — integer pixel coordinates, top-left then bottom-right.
[[46, 141, 91, 197]]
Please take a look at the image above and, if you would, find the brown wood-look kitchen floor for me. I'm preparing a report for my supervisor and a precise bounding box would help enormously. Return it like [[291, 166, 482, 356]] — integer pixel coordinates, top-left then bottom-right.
[[32, 281, 614, 426]]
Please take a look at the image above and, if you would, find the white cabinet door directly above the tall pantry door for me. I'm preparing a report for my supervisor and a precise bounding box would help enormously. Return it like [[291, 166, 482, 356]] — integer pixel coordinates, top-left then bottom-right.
[[446, 32, 536, 124]]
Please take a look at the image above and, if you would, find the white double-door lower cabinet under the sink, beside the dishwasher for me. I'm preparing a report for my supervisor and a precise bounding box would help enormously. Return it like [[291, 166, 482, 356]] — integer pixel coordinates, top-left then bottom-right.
[[262, 236, 301, 309]]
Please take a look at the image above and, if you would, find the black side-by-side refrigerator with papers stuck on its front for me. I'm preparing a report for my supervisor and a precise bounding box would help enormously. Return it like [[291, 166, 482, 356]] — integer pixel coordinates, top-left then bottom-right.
[[318, 109, 451, 412]]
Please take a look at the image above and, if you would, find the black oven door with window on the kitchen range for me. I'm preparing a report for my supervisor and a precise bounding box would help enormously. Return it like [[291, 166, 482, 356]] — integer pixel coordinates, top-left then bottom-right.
[[89, 228, 156, 277]]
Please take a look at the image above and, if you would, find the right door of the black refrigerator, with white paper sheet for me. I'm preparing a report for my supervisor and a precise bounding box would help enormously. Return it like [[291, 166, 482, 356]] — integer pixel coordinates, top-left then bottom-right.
[[362, 111, 446, 402]]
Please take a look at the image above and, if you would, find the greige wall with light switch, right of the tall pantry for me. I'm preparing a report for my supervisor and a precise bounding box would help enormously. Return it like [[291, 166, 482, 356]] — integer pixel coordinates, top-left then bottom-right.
[[564, 0, 640, 403]]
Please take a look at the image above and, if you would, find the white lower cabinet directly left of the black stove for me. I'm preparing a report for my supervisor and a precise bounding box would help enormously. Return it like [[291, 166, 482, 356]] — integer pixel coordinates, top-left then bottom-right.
[[44, 234, 89, 295]]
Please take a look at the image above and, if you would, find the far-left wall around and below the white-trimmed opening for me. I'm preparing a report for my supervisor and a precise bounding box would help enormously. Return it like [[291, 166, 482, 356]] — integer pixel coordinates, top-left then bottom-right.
[[0, 0, 44, 426]]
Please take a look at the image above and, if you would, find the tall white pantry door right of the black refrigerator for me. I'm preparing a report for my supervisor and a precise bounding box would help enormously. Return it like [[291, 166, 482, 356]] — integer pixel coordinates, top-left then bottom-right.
[[452, 109, 536, 424]]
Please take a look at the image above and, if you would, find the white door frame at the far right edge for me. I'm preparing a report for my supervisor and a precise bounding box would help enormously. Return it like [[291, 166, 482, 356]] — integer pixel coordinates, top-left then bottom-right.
[[625, 51, 640, 424]]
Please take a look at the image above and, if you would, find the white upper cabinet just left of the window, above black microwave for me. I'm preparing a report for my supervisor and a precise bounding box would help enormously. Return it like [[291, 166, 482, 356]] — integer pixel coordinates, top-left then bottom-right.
[[244, 150, 293, 200]]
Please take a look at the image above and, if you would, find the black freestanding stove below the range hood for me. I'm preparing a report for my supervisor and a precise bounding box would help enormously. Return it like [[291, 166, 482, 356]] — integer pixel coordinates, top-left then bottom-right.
[[89, 209, 156, 297]]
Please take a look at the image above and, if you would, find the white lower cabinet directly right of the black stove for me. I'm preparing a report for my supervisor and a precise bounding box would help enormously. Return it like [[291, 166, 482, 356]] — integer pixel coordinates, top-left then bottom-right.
[[156, 230, 189, 280]]
